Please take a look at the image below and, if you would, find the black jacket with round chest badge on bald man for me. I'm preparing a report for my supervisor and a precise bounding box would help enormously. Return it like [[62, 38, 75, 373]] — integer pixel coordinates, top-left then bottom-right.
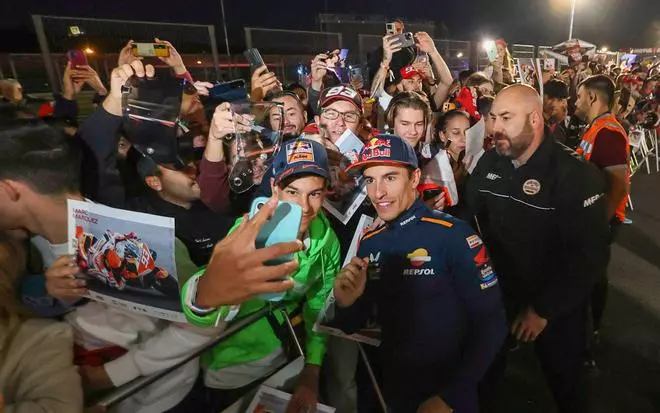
[[464, 137, 609, 319]]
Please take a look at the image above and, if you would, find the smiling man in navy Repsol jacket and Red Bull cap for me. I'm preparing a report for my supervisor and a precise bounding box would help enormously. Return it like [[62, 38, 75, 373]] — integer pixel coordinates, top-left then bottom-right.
[[334, 135, 506, 413]]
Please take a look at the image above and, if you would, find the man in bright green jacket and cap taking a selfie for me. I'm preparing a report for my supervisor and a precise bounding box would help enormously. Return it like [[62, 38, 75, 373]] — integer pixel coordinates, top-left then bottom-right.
[[182, 139, 341, 412]]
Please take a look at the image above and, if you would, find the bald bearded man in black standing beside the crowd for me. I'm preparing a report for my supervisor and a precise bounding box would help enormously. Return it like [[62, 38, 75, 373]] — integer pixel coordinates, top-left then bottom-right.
[[466, 85, 608, 413]]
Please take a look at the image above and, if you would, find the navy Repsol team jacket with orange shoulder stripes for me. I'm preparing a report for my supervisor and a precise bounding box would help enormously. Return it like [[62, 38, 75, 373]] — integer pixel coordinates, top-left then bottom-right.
[[333, 200, 507, 412]]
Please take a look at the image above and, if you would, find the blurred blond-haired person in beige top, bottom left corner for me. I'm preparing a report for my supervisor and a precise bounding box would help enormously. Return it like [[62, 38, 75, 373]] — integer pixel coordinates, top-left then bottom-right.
[[0, 232, 83, 413]]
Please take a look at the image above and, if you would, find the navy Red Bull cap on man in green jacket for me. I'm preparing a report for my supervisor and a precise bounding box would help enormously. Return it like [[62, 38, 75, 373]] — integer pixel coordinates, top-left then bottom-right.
[[273, 138, 330, 184]]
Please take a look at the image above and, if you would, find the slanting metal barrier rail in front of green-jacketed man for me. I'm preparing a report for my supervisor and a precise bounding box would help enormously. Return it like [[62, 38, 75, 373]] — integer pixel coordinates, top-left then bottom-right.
[[95, 302, 302, 408]]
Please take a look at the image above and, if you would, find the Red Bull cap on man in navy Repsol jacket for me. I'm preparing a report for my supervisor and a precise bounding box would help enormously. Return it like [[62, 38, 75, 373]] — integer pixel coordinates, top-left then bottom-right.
[[346, 135, 418, 172]]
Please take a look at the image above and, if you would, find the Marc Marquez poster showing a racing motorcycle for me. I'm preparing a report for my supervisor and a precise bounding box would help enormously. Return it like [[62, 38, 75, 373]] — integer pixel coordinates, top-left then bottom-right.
[[68, 200, 185, 322]]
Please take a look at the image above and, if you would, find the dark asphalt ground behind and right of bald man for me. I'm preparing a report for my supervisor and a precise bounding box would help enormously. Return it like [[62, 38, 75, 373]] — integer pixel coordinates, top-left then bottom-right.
[[498, 171, 660, 413]]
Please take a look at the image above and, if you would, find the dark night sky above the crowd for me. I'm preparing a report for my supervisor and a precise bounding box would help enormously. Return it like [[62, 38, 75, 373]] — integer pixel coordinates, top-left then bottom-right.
[[0, 0, 660, 52]]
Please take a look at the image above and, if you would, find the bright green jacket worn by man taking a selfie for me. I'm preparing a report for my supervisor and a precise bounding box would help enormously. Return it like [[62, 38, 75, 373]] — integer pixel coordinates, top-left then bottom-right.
[[182, 213, 341, 384]]
